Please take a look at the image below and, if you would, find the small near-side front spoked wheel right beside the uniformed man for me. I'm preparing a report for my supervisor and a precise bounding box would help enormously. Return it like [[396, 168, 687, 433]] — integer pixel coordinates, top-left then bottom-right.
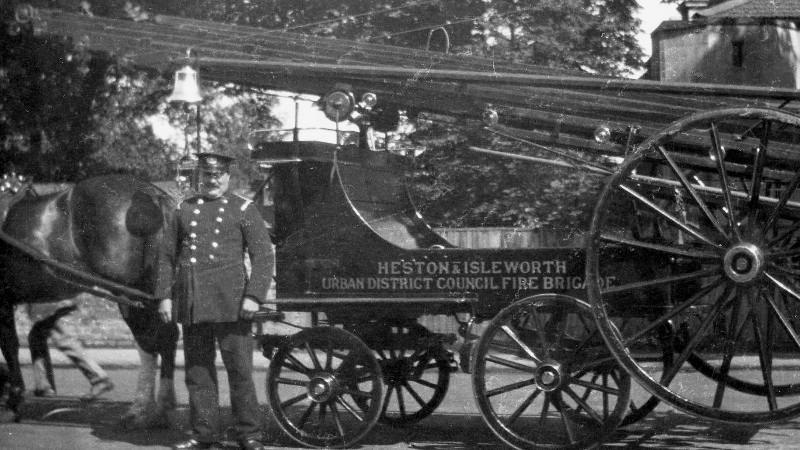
[[267, 327, 383, 448]]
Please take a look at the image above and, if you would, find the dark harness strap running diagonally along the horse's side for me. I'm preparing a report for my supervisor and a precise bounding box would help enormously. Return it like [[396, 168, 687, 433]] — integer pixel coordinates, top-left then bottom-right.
[[0, 173, 158, 308]]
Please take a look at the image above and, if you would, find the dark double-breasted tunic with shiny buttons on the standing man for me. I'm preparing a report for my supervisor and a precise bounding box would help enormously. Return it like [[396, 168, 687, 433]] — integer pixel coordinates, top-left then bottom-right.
[[156, 194, 272, 325]]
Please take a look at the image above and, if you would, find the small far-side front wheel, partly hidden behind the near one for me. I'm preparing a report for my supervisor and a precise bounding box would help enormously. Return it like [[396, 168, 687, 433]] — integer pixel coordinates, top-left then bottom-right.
[[376, 324, 450, 426]]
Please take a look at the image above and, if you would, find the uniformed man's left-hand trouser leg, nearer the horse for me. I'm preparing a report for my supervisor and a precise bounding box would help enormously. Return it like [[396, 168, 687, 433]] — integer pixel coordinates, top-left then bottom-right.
[[183, 324, 219, 443]]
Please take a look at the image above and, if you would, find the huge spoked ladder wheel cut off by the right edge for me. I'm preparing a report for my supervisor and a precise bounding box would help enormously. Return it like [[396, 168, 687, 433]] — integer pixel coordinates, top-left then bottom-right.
[[586, 108, 800, 424]]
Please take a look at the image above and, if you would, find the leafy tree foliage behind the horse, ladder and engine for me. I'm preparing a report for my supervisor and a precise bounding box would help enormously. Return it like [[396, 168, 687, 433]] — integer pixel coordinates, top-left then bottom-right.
[[0, 0, 643, 227]]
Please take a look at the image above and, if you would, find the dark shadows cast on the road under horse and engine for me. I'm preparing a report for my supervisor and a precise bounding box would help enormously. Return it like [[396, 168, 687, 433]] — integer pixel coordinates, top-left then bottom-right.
[[15, 397, 800, 450]]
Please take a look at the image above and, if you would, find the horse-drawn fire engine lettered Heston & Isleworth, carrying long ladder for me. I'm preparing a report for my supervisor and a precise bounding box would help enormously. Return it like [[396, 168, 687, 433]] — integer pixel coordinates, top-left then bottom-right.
[[7, 4, 800, 448]]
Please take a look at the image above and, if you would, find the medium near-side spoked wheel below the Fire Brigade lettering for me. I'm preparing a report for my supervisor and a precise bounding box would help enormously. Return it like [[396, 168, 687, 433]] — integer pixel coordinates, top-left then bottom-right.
[[472, 294, 631, 448]]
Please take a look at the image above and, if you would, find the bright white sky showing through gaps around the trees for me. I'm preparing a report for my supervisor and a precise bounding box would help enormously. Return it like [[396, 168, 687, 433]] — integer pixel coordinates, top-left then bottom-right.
[[156, 0, 680, 147]]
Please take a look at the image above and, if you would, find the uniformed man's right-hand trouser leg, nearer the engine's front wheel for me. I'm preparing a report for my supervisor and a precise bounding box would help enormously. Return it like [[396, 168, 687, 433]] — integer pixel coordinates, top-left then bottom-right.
[[216, 322, 261, 442]]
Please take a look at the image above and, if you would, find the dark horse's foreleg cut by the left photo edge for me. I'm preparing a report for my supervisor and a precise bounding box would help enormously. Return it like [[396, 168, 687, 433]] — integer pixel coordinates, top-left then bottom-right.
[[0, 302, 25, 423]]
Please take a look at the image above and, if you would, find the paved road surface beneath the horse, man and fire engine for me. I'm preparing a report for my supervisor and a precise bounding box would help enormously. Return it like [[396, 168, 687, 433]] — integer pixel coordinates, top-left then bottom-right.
[[0, 356, 800, 450]]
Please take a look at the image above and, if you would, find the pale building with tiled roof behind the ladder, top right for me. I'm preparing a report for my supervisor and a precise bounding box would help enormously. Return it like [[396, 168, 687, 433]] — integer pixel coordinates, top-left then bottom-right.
[[646, 0, 800, 88]]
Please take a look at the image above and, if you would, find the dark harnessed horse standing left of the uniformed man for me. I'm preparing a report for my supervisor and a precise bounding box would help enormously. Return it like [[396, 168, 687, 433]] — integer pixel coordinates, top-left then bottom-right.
[[0, 171, 178, 428]]
